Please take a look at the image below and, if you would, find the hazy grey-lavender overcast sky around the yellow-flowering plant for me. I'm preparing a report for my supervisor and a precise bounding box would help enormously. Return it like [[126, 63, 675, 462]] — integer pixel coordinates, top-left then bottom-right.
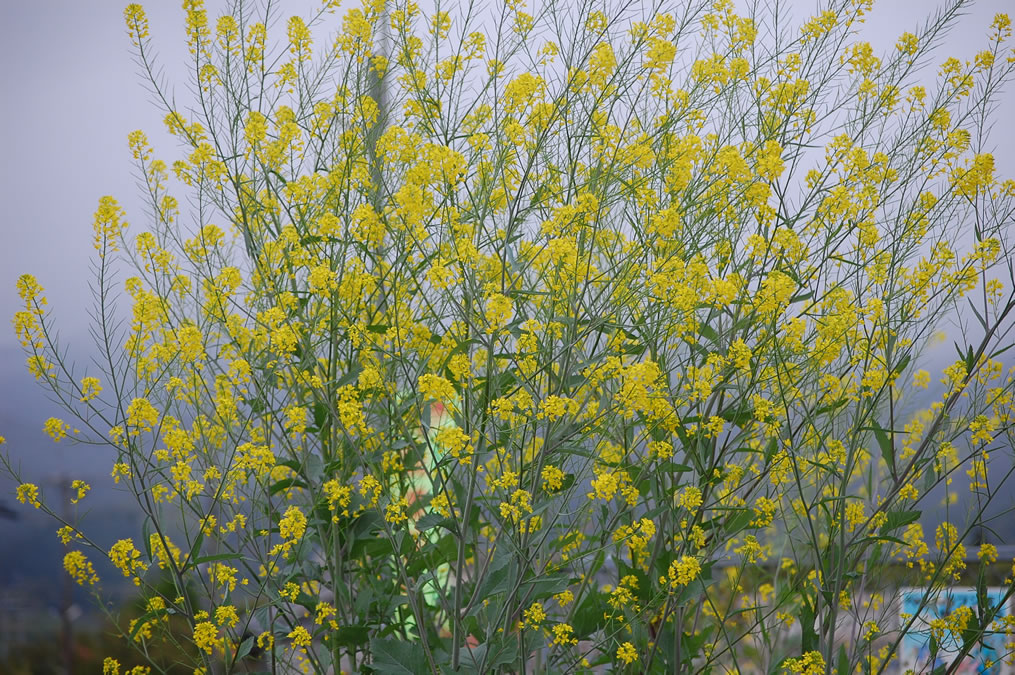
[[0, 0, 1015, 584]]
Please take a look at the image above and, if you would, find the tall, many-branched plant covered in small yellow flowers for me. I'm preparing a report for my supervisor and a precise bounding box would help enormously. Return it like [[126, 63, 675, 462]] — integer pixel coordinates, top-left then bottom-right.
[[4, 0, 1015, 673]]
